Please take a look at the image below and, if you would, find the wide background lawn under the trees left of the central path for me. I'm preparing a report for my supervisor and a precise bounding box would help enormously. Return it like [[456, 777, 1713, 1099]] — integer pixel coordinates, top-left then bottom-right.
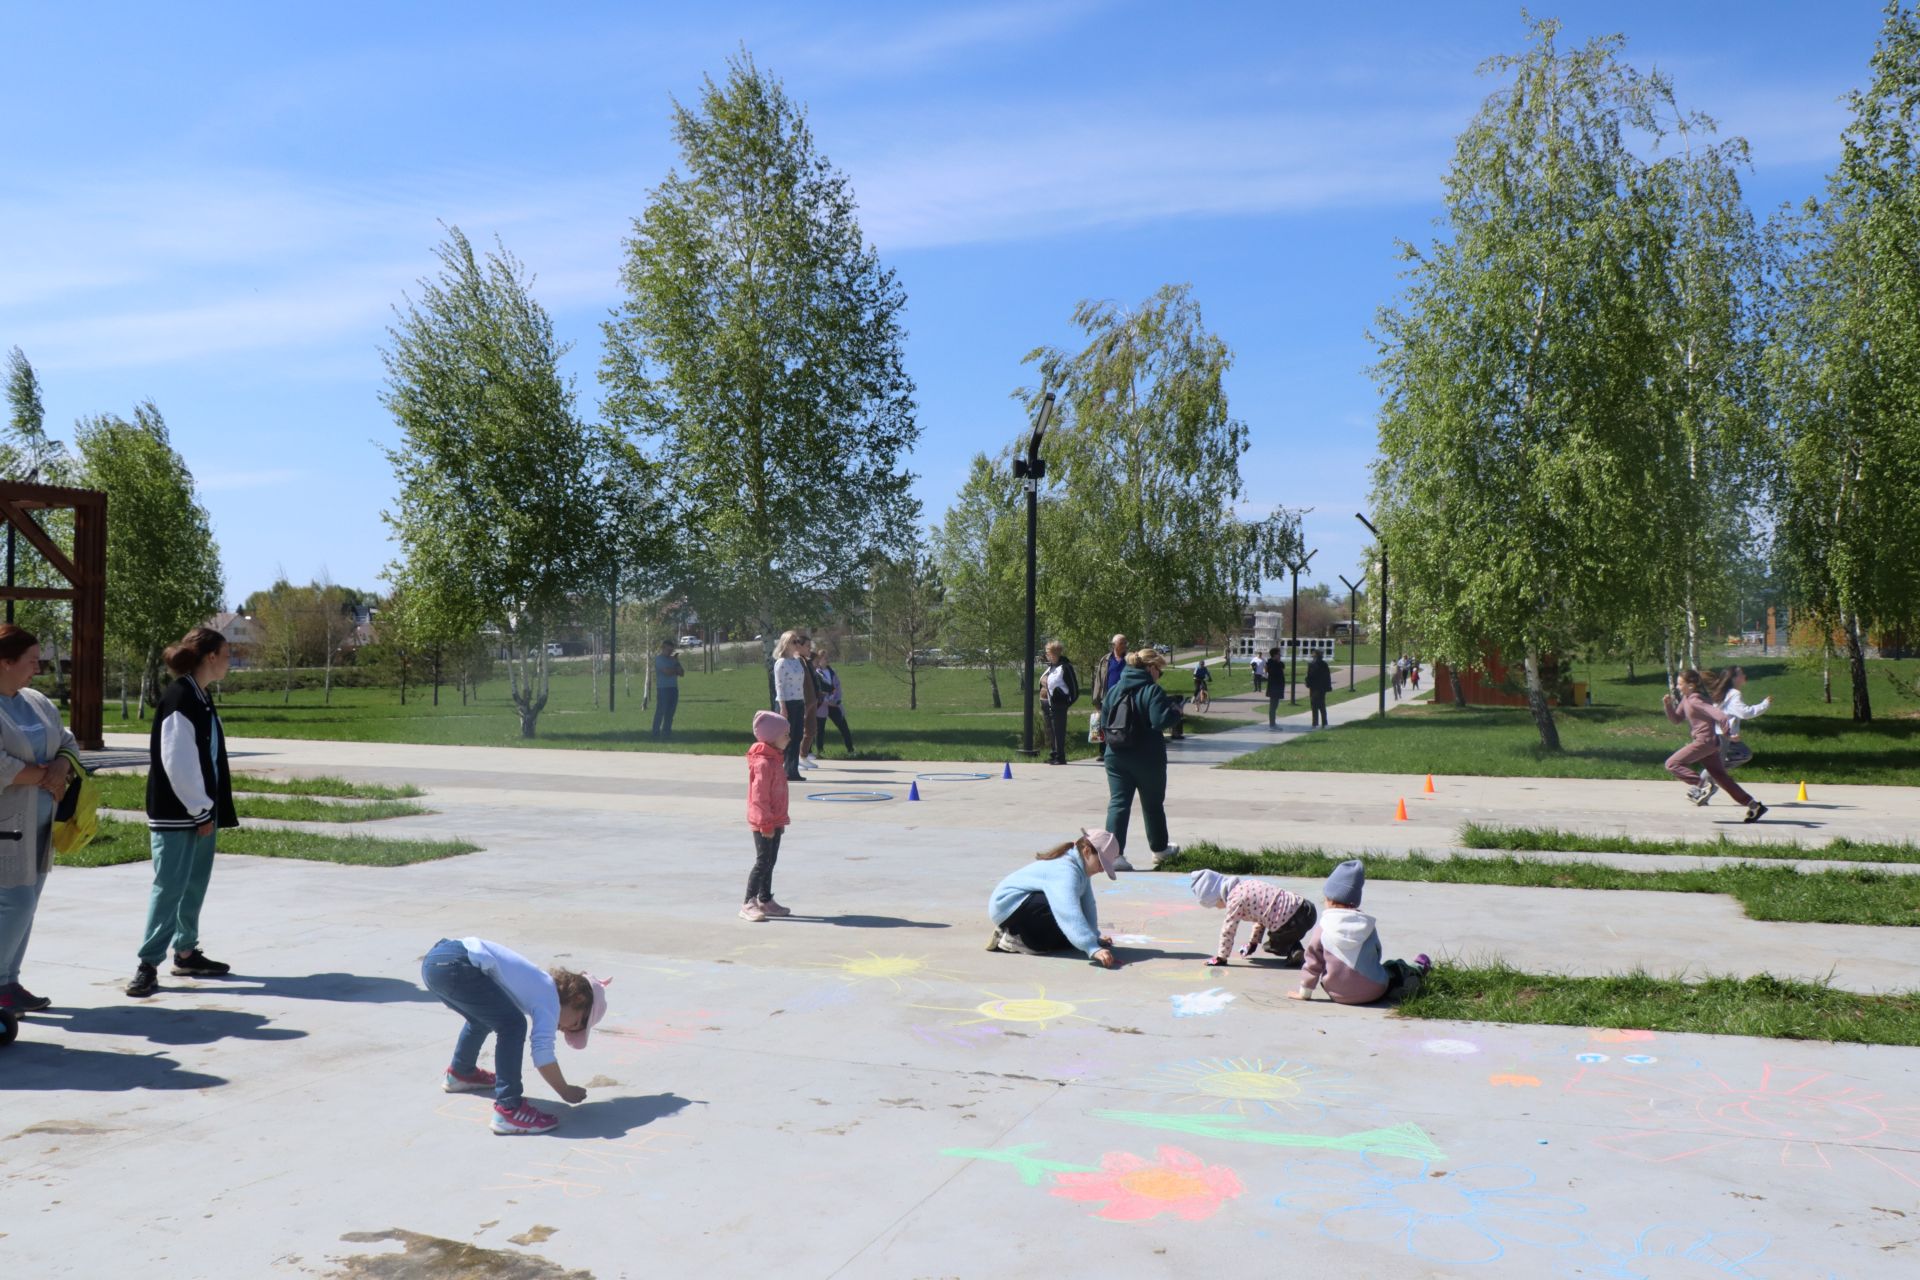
[[90, 662, 1235, 764]]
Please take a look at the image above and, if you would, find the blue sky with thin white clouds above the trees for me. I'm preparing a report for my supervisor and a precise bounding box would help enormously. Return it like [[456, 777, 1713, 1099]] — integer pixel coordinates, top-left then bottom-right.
[[0, 0, 1880, 599]]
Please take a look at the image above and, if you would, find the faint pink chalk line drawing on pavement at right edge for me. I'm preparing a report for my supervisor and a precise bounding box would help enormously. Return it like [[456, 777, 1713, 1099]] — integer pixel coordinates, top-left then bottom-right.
[[1567, 1063, 1920, 1188]]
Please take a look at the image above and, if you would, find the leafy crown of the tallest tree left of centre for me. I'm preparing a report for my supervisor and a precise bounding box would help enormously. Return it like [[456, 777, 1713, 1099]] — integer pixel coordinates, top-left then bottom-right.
[[601, 56, 918, 652]]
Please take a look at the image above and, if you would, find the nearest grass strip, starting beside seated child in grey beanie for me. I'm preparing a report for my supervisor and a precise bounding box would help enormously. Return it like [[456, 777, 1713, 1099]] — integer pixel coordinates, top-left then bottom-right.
[[1398, 961, 1920, 1046]]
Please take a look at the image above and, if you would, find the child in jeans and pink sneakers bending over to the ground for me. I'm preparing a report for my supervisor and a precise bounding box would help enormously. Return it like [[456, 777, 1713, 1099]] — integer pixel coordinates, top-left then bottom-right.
[[420, 938, 607, 1134]]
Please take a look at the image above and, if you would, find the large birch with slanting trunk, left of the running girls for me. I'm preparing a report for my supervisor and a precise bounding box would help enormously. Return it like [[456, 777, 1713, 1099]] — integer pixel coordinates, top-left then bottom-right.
[[1375, 21, 1667, 750]]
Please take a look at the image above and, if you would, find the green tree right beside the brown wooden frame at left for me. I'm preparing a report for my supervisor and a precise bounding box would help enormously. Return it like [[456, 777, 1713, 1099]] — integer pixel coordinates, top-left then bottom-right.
[[75, 401, 223, 700]]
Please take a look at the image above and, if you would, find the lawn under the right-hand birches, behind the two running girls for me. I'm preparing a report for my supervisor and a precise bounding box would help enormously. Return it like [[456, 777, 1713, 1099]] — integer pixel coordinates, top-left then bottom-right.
[[1227, 658, 1920, 786]]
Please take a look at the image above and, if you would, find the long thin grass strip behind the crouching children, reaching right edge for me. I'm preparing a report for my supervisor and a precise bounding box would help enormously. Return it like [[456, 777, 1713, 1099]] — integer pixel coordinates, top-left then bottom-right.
[[1156, 842, 1920, 927]]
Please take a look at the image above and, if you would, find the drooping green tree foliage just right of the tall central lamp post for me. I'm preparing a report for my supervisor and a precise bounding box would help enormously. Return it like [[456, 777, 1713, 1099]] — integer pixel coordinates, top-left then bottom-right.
[[1021, 284, 1274, 660]]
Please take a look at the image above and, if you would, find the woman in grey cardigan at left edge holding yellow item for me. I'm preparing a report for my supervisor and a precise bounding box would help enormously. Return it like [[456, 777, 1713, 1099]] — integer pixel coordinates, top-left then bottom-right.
[[0, 622, 79, 1015]]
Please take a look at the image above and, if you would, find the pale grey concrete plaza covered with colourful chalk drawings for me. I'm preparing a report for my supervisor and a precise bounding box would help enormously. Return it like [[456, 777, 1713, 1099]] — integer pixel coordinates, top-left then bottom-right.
[[0, 739, 1920, 1280]]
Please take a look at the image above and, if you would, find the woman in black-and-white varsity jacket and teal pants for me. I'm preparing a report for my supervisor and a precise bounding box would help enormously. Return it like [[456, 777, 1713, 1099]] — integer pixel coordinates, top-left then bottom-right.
[[127, 628, 240, 996]]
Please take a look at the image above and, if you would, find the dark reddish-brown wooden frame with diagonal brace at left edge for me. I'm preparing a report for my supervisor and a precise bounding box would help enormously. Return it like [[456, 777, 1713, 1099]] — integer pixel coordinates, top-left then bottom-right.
[[0, 480, 108, 750]]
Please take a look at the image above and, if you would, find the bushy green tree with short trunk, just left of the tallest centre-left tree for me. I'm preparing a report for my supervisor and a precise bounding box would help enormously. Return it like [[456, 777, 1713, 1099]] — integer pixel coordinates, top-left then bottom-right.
[[382, 226, 622, 737]]
